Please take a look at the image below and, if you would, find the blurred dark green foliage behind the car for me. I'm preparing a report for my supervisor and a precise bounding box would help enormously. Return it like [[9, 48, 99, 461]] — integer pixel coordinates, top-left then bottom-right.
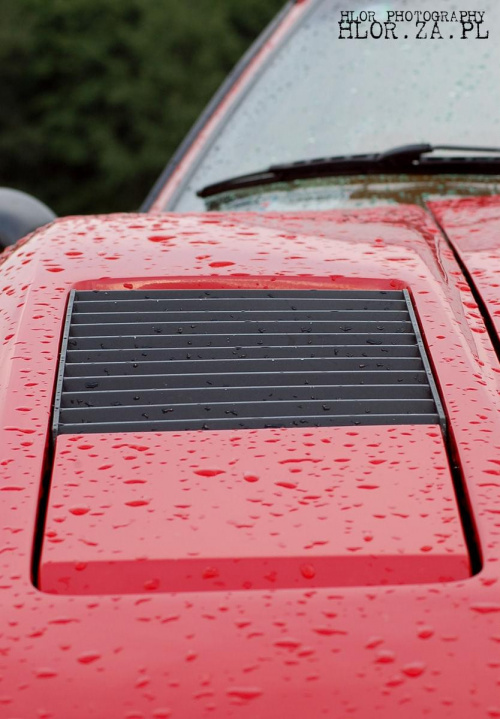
[[0, 0, 284, 215]]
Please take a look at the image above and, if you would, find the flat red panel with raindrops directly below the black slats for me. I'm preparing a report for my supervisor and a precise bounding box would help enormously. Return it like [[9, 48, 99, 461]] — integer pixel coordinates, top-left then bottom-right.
[[40, 426, 470, 594]]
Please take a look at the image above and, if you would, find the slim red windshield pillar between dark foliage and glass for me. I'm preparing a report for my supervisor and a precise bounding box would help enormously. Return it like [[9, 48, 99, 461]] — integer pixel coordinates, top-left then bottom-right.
[[149, 0, 310, 213]]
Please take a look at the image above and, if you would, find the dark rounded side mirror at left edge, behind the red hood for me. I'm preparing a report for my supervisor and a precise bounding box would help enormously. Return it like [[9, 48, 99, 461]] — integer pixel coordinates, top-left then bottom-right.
[[0, 187, 56, 251]]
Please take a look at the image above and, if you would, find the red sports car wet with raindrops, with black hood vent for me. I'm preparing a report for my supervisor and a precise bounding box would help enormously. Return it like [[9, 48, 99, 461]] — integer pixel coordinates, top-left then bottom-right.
[[0, 0, 500, 719]]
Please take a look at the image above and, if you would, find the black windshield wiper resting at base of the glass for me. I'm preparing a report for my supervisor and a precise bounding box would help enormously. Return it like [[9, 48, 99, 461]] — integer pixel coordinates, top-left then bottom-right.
[[196, 143, 500, 197]]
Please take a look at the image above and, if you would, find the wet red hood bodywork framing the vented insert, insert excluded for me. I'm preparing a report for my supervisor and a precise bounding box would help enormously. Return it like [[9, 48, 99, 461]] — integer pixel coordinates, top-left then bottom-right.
[[0, 206, 500, 719]]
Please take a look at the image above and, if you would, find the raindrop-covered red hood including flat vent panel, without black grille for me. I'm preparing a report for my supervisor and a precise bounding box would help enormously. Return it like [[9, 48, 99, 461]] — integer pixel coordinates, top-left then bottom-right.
[[0, 206, 500, 719]]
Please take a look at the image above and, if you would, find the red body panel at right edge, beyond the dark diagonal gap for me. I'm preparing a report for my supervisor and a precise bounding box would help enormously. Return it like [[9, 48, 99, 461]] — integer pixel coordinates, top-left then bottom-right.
[[428, 196, 500, 344]]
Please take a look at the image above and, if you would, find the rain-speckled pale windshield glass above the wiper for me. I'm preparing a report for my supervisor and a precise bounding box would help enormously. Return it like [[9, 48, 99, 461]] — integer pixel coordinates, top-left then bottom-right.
[[169, 0, 500, 211]]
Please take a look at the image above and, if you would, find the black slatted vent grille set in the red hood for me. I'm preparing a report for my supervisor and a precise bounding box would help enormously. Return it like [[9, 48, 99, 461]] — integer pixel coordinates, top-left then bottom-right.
[[53, 290, 444, 435]]
